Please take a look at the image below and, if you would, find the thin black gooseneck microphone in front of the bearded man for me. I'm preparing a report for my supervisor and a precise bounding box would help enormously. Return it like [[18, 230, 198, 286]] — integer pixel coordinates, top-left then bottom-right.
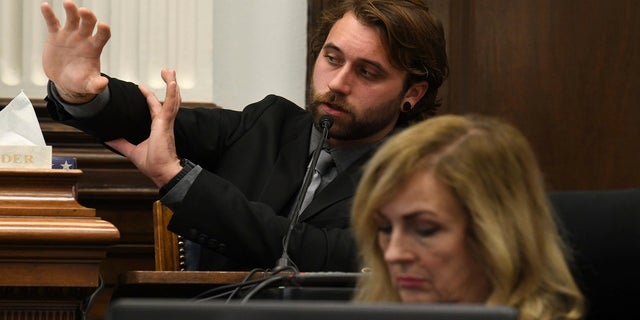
[[274, 114, 333, 272]]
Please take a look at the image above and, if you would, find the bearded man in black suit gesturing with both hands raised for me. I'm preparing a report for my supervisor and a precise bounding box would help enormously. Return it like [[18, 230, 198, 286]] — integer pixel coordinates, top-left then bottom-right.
[[41, 0, 448, 271]]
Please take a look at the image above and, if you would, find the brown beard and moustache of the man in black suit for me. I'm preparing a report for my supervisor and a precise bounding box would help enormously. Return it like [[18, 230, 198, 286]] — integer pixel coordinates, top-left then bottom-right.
[[307, 90, 402, 140]]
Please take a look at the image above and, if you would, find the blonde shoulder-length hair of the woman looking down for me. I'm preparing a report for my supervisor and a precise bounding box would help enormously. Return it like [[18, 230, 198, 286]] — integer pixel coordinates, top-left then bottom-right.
[[352, 115, 584, 320]]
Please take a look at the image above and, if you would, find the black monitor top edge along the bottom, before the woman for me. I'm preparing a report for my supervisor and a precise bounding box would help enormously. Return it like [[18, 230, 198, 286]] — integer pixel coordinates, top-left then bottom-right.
[[106, 298, 518, 320]]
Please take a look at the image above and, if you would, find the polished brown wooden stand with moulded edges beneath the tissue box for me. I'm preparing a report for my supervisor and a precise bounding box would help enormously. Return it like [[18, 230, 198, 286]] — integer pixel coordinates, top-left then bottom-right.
[[0, 169, 120, 320]]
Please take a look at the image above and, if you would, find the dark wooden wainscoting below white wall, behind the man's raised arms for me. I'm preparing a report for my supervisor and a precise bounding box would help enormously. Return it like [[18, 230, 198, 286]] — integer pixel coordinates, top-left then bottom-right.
[[0, 99, 217, 320]]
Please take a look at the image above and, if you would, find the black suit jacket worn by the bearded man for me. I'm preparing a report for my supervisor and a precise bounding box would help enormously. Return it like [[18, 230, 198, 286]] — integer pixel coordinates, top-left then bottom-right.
[[47, 78, 370, 271]]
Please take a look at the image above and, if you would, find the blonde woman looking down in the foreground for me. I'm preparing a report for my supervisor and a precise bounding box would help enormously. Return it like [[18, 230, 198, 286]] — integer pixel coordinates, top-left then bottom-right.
[[352, 115, 584, 320]]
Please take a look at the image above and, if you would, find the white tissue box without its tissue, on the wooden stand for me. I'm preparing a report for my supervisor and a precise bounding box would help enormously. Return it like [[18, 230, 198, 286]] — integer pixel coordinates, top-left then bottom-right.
[[0, 145, 52, 169]]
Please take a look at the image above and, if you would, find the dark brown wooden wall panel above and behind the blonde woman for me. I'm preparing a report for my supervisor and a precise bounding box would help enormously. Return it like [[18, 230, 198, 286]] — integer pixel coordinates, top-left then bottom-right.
[[444, 0, 640, 190]]
